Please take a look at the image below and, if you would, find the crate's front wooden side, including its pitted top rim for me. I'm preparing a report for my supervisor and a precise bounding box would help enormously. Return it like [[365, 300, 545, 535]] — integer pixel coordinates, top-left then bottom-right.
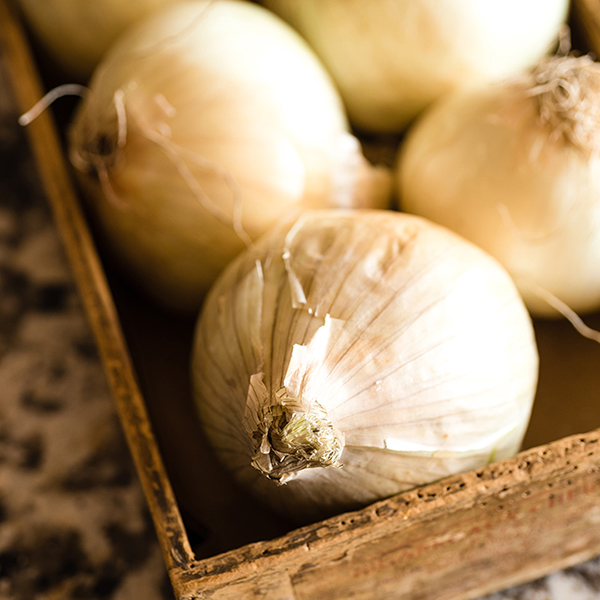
[[174, 432, 600, 600]]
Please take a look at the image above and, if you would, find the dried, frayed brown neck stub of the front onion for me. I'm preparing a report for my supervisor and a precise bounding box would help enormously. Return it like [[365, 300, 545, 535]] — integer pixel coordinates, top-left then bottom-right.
[[252, 388, 344, 483]]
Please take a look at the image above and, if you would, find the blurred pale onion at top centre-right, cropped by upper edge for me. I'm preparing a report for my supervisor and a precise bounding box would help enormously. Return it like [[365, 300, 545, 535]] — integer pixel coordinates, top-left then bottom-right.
[[263, 0, 569, 132]]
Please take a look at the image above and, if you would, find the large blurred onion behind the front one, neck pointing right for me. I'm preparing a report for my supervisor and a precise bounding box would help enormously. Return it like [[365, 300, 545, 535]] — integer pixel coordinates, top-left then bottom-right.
[[70, 0, 390, 311]]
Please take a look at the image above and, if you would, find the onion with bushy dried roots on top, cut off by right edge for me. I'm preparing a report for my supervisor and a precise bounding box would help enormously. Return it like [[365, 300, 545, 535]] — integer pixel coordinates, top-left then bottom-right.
[[397, 56, 600, 316]]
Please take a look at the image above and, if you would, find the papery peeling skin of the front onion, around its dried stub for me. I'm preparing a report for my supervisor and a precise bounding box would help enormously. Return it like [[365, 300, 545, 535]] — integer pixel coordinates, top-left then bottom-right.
[[192, 210, 538, 523]]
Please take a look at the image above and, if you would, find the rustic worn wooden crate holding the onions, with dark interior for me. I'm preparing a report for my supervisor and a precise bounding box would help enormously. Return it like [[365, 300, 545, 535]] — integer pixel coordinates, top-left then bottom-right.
[[0, 0, 600, 600]]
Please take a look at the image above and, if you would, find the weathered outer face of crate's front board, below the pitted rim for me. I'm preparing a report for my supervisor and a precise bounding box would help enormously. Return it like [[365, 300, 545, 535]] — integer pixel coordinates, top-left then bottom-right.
[[292, 479, 600, 600]]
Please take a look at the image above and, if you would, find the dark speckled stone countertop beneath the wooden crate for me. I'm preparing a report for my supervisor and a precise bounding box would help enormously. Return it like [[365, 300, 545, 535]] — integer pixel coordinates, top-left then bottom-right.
[[0, 42, 600, 600]]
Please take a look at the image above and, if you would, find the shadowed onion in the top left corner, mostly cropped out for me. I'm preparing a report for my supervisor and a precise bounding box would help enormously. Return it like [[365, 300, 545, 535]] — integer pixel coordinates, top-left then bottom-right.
[[18, 0, 176, 80]]
